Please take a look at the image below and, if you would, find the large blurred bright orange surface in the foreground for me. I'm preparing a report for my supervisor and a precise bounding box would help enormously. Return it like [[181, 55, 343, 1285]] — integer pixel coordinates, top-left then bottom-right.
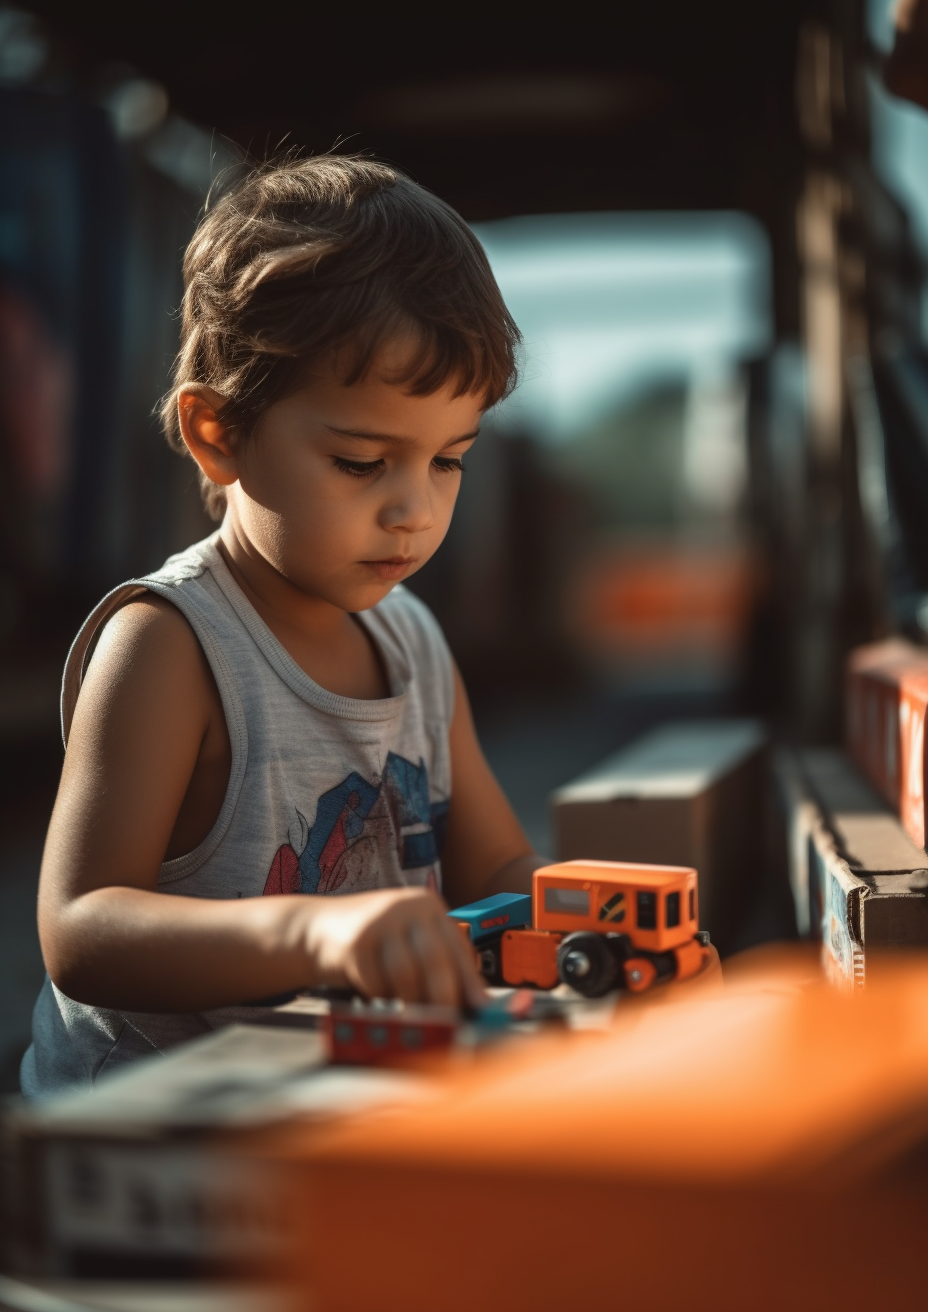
[[257, 954, 928, 1312]]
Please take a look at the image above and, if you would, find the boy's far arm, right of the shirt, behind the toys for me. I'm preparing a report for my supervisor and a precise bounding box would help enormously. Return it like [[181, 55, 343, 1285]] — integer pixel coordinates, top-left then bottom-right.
[[441, 666, 547, 907]]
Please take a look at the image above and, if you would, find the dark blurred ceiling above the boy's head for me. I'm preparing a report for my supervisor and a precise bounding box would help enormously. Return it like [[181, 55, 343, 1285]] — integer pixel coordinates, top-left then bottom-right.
[[26, 0, 803, 226]]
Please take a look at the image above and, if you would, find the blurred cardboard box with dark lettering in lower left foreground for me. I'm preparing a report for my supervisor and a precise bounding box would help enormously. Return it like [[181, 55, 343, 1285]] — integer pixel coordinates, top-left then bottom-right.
[[4, 1017, 433, 1279]]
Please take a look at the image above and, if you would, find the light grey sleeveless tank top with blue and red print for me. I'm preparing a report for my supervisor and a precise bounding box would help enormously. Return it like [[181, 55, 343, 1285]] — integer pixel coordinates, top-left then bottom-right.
[[22, 535, 454, 1097]]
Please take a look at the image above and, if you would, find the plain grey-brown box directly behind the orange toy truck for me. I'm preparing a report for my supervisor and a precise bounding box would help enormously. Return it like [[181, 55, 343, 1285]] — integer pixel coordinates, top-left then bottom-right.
[[551, 720, 765, 953]]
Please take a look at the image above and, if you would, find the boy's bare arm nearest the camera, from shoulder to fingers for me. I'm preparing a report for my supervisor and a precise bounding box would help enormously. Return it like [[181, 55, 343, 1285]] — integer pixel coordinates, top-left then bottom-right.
[[39, 598, 480, 1012]]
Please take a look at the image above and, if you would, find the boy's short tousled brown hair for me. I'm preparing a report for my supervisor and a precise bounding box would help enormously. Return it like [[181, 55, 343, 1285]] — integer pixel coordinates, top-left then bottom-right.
[[161, 155, 520, 518]]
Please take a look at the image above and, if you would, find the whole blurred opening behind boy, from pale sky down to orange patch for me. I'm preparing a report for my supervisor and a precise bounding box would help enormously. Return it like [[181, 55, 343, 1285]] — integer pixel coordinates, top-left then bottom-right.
[[475, 213, 773, 695]]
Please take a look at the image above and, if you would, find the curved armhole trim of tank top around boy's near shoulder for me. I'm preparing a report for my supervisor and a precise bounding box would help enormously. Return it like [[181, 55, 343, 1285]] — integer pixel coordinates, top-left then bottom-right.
[[62, 579, 248, 884]]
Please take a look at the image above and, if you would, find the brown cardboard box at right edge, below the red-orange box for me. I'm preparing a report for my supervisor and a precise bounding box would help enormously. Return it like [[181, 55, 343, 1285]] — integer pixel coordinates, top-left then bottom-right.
[[774, 749, 928, 985]]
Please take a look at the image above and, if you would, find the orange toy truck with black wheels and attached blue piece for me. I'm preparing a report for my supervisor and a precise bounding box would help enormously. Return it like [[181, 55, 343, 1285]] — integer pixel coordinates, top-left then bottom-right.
[[449, 861, 709, 997]]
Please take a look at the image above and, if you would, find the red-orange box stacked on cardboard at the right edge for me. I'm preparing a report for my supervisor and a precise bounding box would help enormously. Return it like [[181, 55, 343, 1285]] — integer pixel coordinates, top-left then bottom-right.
[[845, 638, 928, 848]]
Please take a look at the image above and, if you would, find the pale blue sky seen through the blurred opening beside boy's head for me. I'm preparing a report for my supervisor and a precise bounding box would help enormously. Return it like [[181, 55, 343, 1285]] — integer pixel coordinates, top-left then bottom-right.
[[475, 213, 770, 442]]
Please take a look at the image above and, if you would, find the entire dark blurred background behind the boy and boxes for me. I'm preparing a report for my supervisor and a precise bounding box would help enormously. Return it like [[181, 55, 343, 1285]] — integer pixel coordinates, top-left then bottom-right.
[[0, 0, 928, 1088]]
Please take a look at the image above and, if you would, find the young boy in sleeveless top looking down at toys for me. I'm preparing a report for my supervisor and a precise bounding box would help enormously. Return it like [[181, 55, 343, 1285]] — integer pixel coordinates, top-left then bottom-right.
[[22, 156, 541, 1096]]
